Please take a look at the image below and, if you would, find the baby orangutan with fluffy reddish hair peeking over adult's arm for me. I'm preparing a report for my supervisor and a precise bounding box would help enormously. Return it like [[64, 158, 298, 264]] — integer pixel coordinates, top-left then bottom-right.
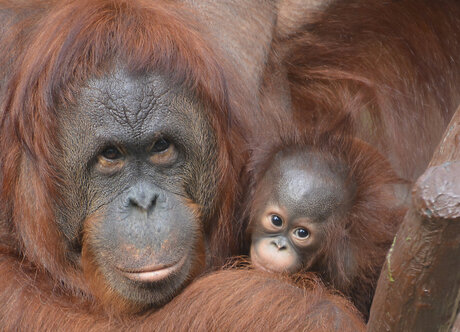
[[249, 134, 405, 315]]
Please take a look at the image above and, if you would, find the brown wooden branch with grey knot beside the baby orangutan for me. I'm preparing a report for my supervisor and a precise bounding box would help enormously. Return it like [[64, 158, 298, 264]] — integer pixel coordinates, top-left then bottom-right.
[[367, 107, 460, 331]]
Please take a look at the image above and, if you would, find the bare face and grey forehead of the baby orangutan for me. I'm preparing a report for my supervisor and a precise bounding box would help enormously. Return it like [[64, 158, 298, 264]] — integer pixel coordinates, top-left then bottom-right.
[[250, 149, 350, 273]]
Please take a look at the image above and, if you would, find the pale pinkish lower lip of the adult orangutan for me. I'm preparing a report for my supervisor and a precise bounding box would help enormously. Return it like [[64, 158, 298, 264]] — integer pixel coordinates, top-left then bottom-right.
[[118, 255, 187, 282]]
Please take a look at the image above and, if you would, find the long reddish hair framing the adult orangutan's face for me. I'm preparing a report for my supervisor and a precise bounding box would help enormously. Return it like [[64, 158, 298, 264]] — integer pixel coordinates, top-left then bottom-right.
[[0, 0, 246, 280]]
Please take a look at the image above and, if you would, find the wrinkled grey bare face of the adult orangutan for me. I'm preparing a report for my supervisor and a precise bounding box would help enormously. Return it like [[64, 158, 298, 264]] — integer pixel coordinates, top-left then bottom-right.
[[59, 68, 217, 305]]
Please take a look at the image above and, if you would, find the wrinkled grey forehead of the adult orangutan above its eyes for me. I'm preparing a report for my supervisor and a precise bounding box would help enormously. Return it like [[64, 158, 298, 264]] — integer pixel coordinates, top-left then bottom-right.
[[67, 69, 209, 148]]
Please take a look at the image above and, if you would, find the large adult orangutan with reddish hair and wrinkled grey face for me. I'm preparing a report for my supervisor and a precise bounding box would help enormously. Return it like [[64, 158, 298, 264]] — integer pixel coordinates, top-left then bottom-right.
[[0, 0, 362, 331]]
